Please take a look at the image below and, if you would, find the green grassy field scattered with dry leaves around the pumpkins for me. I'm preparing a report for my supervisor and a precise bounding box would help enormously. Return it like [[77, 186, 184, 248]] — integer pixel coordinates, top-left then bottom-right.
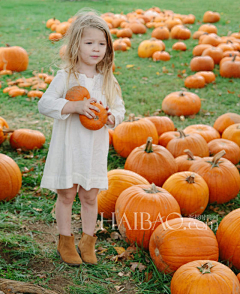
[[0, 0, 240, 294]]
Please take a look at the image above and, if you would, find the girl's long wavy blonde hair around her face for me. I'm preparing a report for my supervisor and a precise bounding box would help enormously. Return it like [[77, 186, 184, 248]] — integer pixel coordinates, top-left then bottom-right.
[[62, 10, 122, 107]]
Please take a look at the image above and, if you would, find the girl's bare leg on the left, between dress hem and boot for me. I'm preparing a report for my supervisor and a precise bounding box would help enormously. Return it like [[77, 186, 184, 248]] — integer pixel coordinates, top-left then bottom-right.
[[56, 184, 77, 236]]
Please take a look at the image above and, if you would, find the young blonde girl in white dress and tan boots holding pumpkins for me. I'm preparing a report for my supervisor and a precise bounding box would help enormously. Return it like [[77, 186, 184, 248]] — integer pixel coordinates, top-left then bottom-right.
[[38, 12, 125, 265]]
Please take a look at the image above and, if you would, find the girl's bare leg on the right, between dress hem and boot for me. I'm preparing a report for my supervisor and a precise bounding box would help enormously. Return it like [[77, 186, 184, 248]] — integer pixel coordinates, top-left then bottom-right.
[[78, 187, 98, 236]]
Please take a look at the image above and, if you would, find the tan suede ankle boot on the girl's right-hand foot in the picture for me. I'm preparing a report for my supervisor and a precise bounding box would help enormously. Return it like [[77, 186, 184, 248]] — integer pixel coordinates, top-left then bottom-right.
[[77, 233, 97, 264]]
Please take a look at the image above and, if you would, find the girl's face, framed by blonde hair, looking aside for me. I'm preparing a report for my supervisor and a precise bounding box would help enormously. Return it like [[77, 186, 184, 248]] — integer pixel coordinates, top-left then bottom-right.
[[79, 28, 107, 66]]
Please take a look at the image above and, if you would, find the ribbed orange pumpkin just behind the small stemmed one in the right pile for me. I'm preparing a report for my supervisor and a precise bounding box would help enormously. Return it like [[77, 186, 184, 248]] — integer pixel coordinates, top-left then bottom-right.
[[166, 134, 209, 157]]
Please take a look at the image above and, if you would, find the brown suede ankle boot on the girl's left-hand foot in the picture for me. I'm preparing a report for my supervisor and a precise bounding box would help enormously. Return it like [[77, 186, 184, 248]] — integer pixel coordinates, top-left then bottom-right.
[[57, 234, 82, 266]]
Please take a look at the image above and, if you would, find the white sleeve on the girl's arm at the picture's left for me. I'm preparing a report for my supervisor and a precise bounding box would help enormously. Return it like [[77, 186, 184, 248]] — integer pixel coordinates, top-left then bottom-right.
[[38, 71, 69, 119]]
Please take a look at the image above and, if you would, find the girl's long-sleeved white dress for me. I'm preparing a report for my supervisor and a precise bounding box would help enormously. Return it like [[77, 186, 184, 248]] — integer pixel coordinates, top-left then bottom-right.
[[38, 70, 125, 192]]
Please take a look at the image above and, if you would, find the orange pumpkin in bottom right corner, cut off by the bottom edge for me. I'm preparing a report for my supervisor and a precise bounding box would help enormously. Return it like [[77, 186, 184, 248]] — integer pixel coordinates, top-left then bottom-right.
[[171, 260, 240, 294]]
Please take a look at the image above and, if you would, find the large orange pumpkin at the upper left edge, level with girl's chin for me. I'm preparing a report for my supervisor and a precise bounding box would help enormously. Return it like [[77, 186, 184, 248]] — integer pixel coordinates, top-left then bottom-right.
[[0, 46, 28, 71]]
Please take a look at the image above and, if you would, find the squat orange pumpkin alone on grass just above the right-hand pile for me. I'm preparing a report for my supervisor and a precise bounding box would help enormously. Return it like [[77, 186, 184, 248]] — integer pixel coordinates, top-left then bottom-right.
[[162, 91, 201, 116]]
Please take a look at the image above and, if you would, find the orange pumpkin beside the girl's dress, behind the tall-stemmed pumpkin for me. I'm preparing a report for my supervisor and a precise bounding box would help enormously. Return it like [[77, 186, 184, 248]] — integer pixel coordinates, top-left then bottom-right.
[[113, 119, 158, 158]]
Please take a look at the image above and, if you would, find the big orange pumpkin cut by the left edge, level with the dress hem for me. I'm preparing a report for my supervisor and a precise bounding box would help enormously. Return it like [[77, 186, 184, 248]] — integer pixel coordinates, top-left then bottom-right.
[[0, 154, 22, 201]]
